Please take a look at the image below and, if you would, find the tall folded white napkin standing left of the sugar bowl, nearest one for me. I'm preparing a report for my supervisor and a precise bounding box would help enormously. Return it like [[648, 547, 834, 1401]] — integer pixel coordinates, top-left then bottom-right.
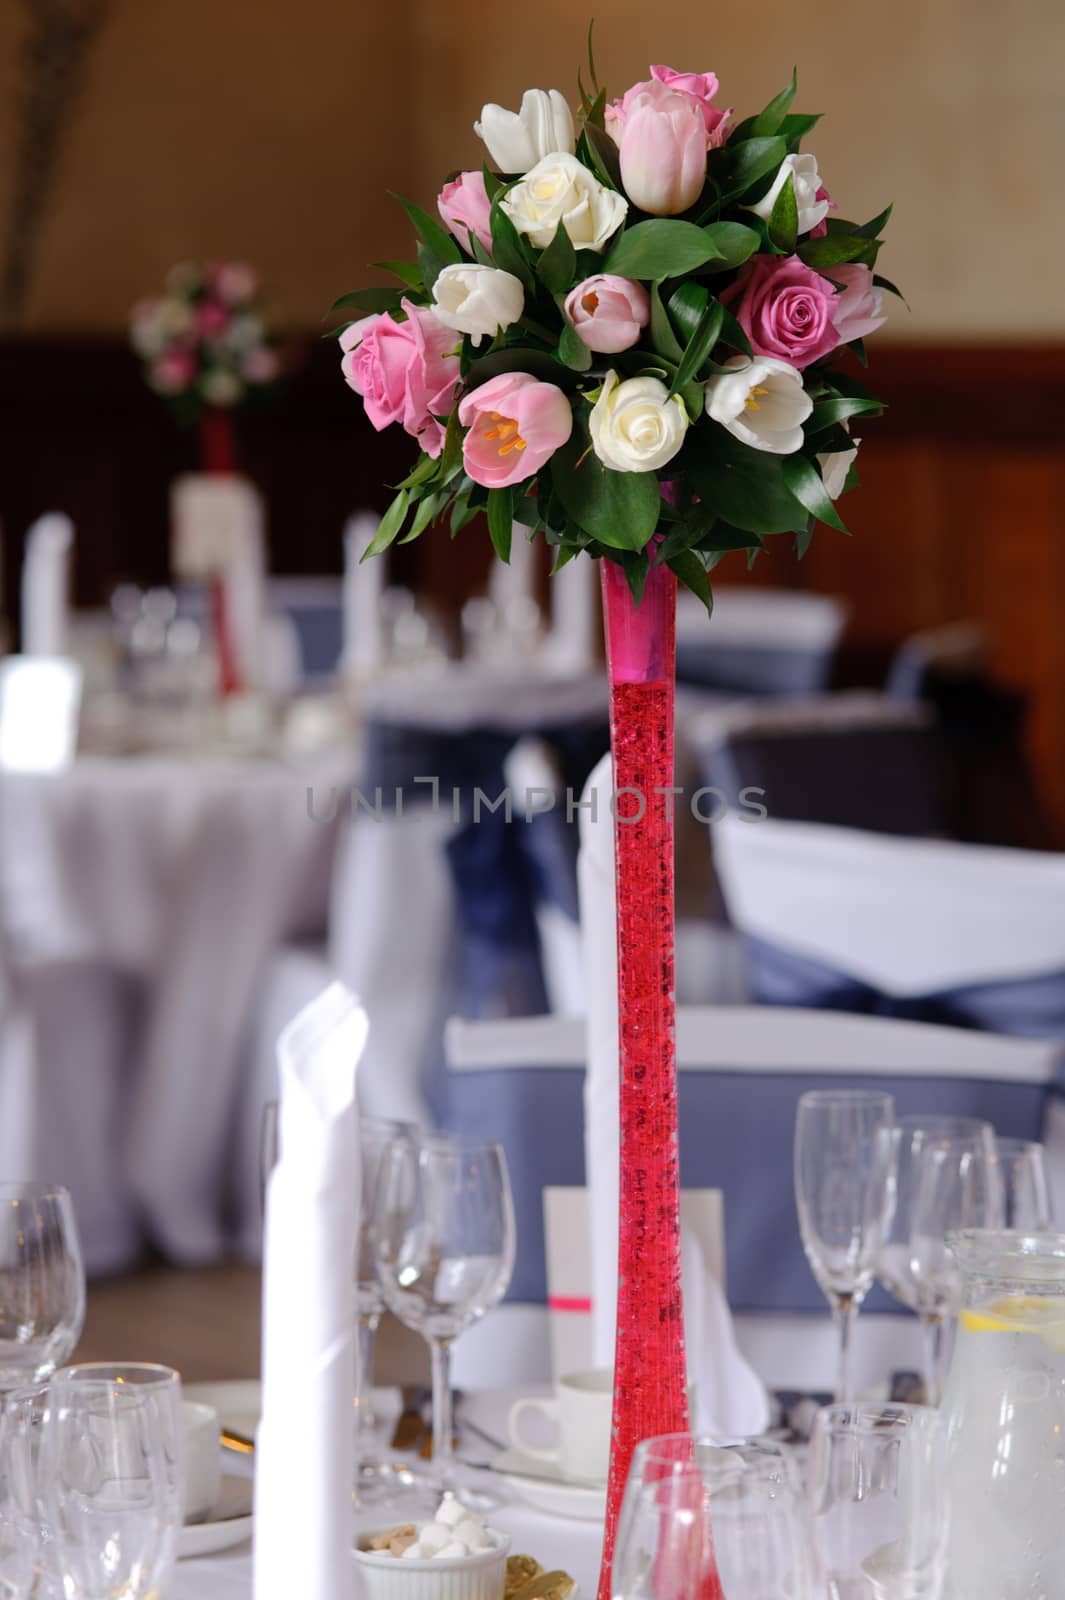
[[254, 984, 366, 1600]]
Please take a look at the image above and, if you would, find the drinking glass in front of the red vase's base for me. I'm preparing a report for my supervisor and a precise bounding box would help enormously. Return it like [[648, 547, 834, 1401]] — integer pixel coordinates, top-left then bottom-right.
[[612, 1434, 814, 1600]]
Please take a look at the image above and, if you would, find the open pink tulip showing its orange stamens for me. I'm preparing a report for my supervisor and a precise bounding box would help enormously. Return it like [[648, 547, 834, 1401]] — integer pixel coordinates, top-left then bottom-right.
[[459, 373, 572, 490]]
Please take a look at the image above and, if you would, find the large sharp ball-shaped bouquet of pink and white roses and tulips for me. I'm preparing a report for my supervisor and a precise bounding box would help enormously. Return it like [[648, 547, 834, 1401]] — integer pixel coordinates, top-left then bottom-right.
[[334, 48, 899, 605]]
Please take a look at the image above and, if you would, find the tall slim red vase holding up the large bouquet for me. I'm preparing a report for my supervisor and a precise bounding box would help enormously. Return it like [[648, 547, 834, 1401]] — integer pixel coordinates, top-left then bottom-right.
[[598, 560, 720, 1600]]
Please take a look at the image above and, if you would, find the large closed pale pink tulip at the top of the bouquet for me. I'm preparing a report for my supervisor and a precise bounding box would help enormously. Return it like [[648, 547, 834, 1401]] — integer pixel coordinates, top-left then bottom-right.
[[620, 80, 707, 216]]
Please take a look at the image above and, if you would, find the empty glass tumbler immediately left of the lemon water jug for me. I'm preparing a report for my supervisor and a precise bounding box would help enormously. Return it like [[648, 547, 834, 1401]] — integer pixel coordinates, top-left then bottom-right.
[[808, 1405, 950, 1600]]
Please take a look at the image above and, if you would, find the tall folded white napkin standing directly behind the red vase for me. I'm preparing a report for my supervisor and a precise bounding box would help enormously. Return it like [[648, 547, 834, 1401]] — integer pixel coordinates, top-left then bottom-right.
[[577, 755, 769, 1435]]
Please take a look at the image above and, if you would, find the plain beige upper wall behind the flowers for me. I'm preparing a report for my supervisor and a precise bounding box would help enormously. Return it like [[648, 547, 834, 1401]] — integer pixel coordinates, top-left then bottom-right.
[[0, 0, 1065, 339]]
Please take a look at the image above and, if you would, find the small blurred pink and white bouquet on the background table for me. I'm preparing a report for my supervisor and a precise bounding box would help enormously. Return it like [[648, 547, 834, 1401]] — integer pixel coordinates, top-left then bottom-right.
[[130, 261, 281, 421]]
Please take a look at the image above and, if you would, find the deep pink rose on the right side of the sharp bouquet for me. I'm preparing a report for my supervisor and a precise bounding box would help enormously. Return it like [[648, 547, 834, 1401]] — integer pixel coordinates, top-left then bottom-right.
[[721, 256, 840, 368]]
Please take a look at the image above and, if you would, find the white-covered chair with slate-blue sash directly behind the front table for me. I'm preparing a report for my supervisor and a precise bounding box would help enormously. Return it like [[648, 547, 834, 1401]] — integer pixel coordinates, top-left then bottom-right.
[[446, 1006, 1065, 1389]]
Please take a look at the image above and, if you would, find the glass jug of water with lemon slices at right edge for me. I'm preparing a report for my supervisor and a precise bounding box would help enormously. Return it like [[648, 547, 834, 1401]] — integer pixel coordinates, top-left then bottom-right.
[[943, 1229, 1065, 1600]]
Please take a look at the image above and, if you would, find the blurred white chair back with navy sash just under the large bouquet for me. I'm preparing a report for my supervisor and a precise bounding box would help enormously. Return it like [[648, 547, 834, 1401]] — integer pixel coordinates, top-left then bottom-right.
[[676, 584, 846, 698]]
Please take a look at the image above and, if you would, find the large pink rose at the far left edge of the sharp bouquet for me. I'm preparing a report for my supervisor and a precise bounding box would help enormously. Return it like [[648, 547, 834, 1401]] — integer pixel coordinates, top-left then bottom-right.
[[341, 299, 459, 456]]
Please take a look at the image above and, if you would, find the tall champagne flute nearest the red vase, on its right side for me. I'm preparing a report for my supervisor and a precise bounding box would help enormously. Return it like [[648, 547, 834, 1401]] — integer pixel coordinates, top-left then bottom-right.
[[795, 1090, 895, 1400]]
